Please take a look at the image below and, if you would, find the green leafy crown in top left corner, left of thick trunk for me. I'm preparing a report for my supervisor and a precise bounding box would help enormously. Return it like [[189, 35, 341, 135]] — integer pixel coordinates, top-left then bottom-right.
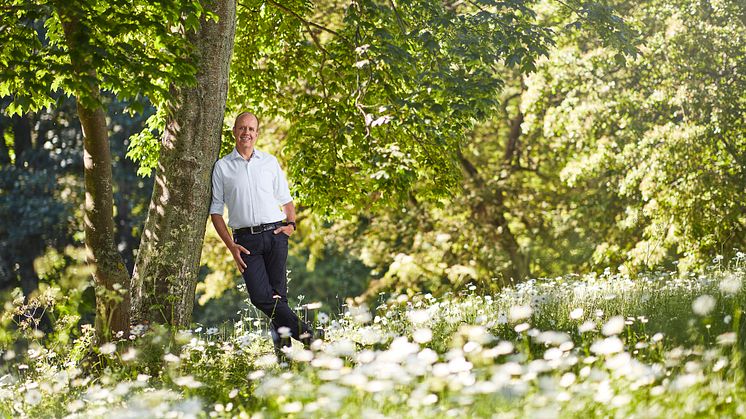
[[0, 0, 204, 115]]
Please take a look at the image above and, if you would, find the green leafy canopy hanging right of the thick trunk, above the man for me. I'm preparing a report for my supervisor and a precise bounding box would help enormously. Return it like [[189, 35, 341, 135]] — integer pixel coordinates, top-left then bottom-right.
[[151, 1, 634, 216]]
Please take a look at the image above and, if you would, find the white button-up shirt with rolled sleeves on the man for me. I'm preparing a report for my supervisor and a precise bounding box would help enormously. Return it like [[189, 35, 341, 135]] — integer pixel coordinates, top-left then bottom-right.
[[210, 148, 293, 230]]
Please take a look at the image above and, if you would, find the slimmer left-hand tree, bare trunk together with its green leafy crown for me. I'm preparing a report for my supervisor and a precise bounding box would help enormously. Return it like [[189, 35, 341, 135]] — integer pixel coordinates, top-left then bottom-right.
[[0, 0, 201, 338]]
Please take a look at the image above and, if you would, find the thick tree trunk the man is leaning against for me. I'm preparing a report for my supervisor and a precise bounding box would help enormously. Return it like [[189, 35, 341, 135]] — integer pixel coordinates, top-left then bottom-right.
[[132, 0, 236, 326]]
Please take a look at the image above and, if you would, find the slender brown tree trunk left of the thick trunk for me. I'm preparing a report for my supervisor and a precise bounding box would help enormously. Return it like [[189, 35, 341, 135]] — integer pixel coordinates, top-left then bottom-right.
[[60, 11, 130, 341]]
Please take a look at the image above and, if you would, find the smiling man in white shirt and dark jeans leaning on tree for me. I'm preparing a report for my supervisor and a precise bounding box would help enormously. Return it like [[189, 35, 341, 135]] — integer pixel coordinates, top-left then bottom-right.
[[210, 112, 313, 356]]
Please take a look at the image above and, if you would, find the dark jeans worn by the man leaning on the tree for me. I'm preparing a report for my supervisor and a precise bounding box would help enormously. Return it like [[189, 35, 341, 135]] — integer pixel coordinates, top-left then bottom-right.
[[233, 230, 312, 346]]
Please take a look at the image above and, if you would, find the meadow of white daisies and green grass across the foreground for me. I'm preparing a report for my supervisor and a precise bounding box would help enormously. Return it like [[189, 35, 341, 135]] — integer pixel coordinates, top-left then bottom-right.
[[0, 253, 746, 418]]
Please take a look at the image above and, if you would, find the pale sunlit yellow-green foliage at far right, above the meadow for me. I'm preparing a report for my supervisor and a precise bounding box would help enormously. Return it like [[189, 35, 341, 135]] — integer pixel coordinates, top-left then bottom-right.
[[524, 1, 746, 268]]
